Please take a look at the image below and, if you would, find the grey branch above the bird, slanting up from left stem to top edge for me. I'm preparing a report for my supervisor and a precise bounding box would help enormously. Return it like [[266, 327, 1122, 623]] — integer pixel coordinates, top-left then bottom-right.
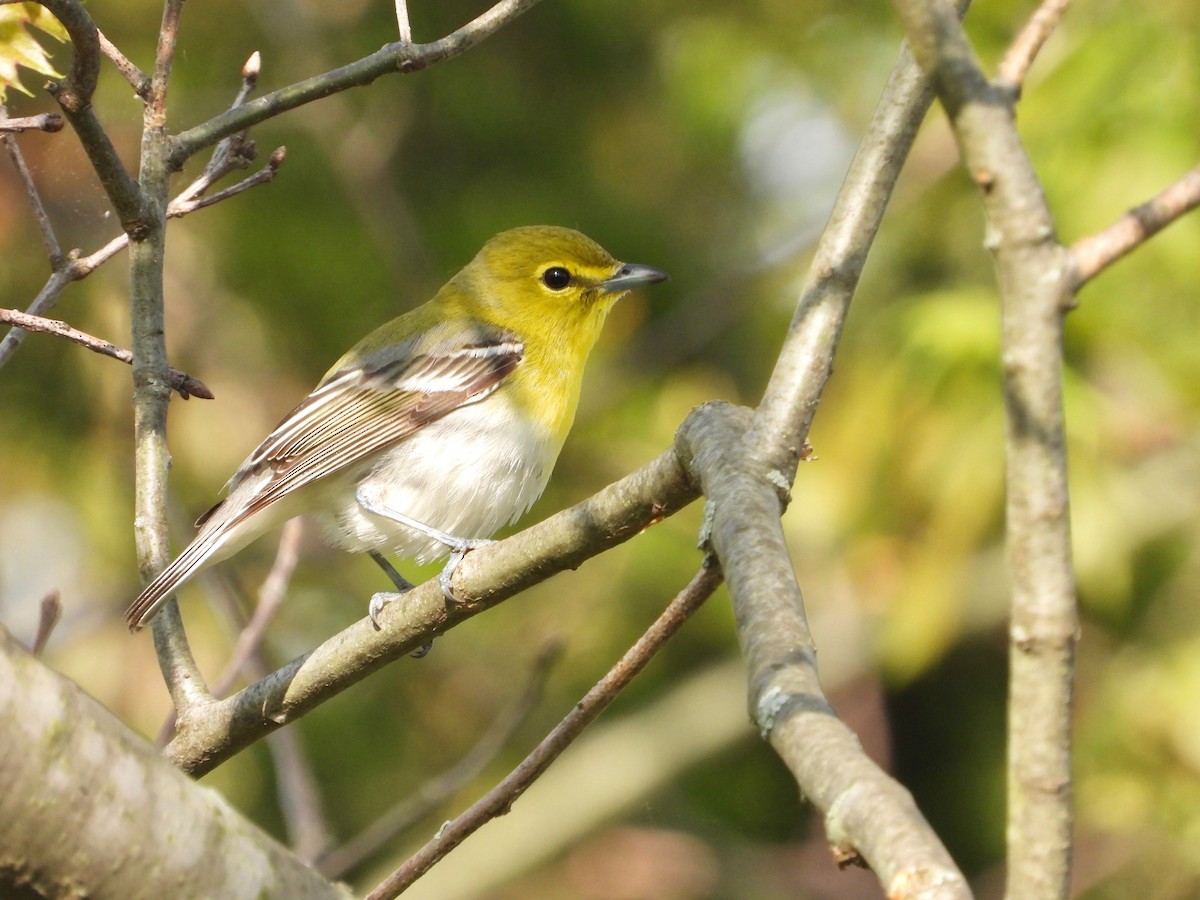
[[169, 0, 539, 169]]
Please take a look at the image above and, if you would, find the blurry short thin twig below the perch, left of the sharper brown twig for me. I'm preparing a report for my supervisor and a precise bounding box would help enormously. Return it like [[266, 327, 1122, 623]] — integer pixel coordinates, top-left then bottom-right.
[[319, 641, 563, 878]]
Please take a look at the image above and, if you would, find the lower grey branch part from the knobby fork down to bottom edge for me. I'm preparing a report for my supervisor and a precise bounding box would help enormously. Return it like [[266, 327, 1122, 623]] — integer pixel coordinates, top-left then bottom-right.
[[679, 403, 970, 900]]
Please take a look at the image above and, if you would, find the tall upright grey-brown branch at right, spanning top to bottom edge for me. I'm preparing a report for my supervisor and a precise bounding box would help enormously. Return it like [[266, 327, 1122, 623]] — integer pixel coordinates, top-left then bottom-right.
[[895, 0, 1079, 898]]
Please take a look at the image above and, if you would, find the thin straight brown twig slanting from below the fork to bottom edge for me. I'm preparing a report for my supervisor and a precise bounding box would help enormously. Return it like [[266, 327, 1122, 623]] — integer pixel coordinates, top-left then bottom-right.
[[367, 559, 721, 900]]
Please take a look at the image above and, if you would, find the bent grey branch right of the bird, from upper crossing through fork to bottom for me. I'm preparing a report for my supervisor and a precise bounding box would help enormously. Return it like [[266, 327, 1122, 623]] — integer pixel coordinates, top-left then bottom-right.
[[729, 14, 970, 898]]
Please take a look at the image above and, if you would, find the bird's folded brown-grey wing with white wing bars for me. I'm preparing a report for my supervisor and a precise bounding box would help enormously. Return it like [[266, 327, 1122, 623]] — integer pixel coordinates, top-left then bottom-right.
[[197, 332, 524, 527]]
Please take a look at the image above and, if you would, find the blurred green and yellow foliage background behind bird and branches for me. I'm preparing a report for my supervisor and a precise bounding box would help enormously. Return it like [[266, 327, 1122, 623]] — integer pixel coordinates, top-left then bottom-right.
[[0, 0, 1200, 900]]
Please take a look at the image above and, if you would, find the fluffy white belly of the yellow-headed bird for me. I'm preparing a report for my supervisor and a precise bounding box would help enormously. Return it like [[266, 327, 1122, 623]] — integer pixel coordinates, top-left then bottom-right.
[[318, 395, 562, 563]]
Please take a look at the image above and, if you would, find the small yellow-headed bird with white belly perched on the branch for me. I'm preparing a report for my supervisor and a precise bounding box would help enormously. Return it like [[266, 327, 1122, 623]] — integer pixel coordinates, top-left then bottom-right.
[[125, 226, 668, 631]]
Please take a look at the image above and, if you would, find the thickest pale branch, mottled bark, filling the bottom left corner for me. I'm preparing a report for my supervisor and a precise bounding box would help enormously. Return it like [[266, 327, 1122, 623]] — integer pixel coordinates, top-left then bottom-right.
[[0, 628, 348, 898]]
